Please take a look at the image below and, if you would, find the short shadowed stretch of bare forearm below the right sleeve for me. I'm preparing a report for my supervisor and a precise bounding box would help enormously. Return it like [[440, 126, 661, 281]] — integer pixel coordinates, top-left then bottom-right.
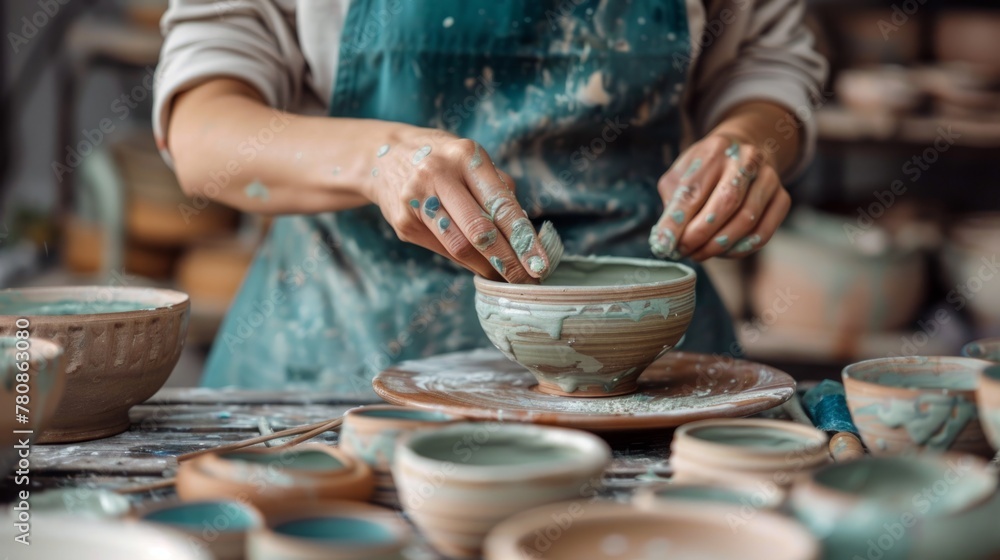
[[710, 101, 802, 175]]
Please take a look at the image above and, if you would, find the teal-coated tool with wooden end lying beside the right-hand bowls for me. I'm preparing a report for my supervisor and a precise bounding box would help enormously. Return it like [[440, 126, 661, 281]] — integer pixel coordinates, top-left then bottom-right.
[[802, 379, 866, 463]]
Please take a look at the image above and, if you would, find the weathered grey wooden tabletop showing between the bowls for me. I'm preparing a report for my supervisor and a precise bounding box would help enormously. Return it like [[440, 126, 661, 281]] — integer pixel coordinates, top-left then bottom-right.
[[0, 388, 672, 559]]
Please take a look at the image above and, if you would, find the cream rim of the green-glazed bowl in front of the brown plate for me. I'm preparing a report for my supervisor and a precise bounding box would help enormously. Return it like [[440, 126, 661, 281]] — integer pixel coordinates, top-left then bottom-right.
[[392, 422, 612, 483]]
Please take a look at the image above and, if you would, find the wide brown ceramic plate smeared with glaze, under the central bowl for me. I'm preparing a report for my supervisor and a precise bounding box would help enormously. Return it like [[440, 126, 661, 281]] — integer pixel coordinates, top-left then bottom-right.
[[372, 350, 795, 432]]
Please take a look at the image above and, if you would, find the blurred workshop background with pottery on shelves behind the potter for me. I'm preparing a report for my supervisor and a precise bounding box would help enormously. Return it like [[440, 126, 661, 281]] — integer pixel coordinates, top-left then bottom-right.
[[0, 0, 1000, 386]]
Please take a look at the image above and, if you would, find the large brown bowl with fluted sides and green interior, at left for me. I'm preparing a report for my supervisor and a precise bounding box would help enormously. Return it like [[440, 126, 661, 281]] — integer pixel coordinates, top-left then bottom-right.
[[0, 286, 190, 443]]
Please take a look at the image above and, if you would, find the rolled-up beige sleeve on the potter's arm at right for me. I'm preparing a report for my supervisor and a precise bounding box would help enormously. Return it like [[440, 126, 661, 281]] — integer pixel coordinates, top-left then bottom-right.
[[690, 0, 827, 180]]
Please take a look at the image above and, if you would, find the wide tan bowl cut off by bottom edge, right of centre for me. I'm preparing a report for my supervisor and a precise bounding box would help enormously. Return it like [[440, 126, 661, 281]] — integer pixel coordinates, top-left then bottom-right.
[[483, 502, 819, 560]]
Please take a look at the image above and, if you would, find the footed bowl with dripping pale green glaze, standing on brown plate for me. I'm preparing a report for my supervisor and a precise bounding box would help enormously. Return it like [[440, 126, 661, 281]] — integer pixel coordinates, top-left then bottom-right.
[[475, 256, 695, 397]]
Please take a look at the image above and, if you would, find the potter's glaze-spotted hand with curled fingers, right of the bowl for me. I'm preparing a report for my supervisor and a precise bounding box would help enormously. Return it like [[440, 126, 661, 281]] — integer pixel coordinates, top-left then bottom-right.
[[649, 134, 791, 261]]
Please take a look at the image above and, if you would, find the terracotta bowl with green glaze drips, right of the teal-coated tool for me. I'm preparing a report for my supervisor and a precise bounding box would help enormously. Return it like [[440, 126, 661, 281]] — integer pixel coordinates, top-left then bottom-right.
[[843, 356, 992, 456]]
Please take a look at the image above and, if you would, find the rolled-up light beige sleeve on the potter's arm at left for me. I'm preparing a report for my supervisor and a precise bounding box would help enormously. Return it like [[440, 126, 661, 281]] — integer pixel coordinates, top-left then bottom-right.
[[153, 0, 305, 161]]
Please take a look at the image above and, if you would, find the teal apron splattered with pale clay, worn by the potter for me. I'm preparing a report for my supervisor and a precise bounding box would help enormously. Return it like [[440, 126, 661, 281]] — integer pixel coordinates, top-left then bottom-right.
[[204, 0, 735, 393]]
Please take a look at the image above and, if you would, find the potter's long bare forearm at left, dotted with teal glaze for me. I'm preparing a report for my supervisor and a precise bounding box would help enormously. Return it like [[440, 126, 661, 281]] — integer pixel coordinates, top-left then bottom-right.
[[167, 79, 413, 214]]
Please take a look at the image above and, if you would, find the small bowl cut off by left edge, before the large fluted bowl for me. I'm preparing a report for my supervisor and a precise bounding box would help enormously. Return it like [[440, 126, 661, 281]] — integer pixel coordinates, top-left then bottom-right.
[[0, 330, 66, 476]]
